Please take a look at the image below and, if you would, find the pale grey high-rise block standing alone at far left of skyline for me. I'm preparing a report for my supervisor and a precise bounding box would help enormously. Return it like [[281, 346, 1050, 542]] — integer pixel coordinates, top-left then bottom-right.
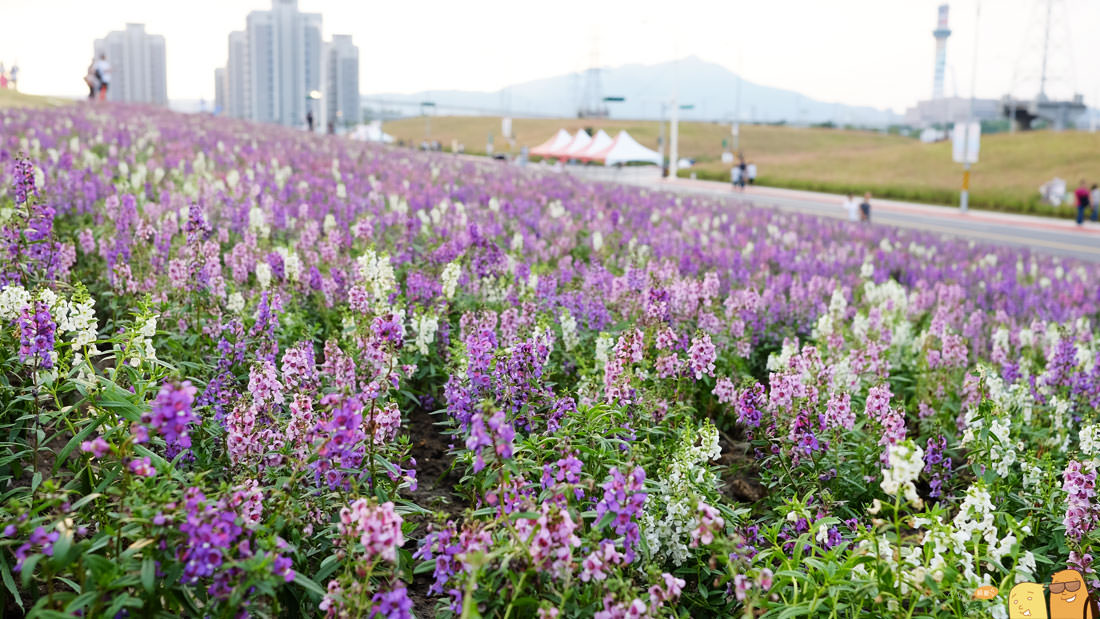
[[92, 24, 168, 106]]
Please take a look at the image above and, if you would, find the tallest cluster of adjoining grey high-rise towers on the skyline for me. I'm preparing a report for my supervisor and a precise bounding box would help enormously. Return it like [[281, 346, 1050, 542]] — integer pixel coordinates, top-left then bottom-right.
[[218, 0, 359, 129]]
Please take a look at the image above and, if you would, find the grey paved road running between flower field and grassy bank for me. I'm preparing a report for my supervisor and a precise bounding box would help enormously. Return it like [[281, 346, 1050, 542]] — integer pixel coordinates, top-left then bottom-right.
[[567, 169, 1100, 262]]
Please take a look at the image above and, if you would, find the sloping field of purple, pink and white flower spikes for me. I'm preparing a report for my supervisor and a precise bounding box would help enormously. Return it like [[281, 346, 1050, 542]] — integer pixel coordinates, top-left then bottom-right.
[[0, 106, 1100, 619]]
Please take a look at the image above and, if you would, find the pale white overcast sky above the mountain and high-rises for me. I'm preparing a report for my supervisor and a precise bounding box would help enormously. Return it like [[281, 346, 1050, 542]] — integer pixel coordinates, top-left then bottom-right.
[[0, 0, 1100, 112]]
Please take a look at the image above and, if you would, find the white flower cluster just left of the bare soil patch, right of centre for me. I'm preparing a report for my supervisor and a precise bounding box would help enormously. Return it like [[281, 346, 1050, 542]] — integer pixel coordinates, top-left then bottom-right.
[[641, 422, 722, 565]]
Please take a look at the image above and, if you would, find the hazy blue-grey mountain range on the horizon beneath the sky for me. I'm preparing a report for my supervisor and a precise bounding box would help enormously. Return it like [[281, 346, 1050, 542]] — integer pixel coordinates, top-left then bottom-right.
[[363, 56, 900, 125]]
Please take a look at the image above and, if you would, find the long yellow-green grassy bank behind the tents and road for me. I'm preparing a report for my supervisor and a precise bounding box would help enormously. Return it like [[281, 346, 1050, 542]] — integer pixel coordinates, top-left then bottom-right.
[[385, 117, 1100, 217]]
